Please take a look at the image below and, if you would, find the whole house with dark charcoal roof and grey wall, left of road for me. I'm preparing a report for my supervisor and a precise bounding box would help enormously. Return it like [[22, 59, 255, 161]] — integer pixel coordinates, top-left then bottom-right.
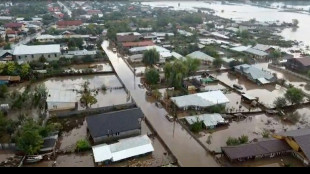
[[86, 108, 144, 144]]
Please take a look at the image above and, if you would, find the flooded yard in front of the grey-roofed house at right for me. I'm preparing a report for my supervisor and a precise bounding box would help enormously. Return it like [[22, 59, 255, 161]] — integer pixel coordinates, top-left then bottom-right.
[[213, 72, 287, 107]]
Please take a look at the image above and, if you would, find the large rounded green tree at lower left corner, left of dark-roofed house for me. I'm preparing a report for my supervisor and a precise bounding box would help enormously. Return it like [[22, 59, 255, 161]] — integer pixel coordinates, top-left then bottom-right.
[[16, 120, 44, 155]]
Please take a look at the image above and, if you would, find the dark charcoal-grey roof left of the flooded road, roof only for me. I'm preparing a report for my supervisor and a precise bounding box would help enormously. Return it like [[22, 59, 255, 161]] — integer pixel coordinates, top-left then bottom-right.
[[86, 108, 144, 138]]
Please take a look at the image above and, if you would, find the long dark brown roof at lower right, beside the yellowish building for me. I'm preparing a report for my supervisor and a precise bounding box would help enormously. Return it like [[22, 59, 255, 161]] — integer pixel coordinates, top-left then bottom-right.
[[222, 139, 292, 160]]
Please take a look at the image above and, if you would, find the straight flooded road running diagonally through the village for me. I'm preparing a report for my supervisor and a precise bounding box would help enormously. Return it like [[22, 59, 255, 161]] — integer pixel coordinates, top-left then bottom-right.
[[102, 41, 219, 167]]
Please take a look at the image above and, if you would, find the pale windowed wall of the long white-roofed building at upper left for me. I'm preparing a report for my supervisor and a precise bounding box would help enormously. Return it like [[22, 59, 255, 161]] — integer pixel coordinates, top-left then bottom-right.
[[15, 53, 61, 62]]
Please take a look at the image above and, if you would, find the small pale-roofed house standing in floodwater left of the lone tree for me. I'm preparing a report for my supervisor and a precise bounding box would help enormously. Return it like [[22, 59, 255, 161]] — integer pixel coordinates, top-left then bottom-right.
[[46, 89, 78, 111]]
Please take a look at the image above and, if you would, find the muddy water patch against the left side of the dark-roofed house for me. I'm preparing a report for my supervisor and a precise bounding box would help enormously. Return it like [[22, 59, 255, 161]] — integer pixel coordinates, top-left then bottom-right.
[[59, 121, 87, 152]]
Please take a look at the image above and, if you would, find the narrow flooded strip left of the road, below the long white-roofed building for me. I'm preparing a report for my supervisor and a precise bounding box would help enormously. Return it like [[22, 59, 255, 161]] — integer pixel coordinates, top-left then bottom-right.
[[65, 63, 113, 72]]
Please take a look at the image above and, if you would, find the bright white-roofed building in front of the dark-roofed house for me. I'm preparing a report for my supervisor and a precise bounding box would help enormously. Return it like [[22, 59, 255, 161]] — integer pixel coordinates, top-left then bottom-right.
[[92, 135, 154, 165]]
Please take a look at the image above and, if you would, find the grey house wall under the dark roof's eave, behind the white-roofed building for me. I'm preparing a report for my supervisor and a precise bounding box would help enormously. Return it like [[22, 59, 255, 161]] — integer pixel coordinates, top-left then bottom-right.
[[93, 129, 141, 144]]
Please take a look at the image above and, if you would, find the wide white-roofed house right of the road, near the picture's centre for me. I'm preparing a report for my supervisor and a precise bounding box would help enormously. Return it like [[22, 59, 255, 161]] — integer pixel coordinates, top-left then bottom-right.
[[171, 91, 229, 110]]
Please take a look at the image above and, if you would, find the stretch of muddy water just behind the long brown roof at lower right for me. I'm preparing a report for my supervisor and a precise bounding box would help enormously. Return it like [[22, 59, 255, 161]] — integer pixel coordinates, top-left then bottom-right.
[[199, 114, 306, 152]]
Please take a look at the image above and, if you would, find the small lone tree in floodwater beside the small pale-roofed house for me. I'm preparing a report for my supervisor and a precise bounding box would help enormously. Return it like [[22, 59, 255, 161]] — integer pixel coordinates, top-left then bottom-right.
[[79, 81, 98, 109]]
